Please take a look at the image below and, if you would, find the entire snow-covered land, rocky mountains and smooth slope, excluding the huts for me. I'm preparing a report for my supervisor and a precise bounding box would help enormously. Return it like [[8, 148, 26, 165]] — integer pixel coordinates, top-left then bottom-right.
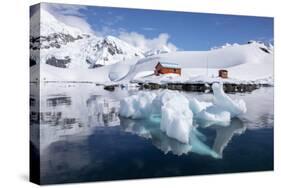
[[30, 9, 274, 83]]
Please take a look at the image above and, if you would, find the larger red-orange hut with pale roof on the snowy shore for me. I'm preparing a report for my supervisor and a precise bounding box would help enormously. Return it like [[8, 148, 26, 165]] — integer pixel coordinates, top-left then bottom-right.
[[154, 62, 181, 76]]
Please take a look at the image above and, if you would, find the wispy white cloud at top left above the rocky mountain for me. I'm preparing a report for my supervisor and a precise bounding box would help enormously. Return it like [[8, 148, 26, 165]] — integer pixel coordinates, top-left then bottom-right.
[[42, 3, 94, 33]]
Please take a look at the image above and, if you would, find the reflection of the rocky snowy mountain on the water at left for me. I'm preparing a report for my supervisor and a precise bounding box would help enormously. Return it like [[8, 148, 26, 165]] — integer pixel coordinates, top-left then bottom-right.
[[30, 92, 120, 150]]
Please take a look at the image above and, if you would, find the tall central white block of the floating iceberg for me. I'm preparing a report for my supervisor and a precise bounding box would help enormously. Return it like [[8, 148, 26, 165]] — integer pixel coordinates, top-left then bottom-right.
[[160, 94, 193, 144]]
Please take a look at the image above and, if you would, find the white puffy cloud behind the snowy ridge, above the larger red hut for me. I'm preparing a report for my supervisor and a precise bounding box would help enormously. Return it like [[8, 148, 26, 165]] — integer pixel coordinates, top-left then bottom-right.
[[119, 32, 177, 51]]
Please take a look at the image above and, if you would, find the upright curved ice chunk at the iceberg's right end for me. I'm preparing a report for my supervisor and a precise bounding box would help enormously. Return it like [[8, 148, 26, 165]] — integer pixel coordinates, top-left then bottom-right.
[[212, 83, 247, 117]]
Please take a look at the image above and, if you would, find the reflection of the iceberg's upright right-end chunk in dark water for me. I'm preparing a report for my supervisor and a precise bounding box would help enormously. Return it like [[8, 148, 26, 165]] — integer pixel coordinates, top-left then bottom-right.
[[213, 118, 246, 157]]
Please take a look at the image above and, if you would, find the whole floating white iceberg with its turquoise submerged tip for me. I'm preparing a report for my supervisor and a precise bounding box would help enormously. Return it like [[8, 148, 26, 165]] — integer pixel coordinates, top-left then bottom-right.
[[120, 83, 246, 158]]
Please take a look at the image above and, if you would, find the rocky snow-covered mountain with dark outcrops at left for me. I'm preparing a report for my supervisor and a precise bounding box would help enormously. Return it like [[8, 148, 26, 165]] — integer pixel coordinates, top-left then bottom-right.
[[30, 9, 144, 69]]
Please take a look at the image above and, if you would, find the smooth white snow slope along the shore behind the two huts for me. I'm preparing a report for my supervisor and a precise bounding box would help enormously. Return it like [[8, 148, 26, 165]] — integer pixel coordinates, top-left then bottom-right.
[[32, 40, 274, 84]]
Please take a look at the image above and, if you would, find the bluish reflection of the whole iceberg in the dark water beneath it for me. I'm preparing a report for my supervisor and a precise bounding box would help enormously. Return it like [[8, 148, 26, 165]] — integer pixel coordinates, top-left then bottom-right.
[[120, 118, 246, 158]]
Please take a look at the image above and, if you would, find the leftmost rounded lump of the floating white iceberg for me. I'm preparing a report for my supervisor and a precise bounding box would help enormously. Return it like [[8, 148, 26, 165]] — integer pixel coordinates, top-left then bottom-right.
[[119, 92, 156, 119]]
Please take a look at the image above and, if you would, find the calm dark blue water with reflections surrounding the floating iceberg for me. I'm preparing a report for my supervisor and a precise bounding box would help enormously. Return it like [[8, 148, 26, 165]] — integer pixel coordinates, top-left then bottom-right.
[[31, 84, 274, 184]]
